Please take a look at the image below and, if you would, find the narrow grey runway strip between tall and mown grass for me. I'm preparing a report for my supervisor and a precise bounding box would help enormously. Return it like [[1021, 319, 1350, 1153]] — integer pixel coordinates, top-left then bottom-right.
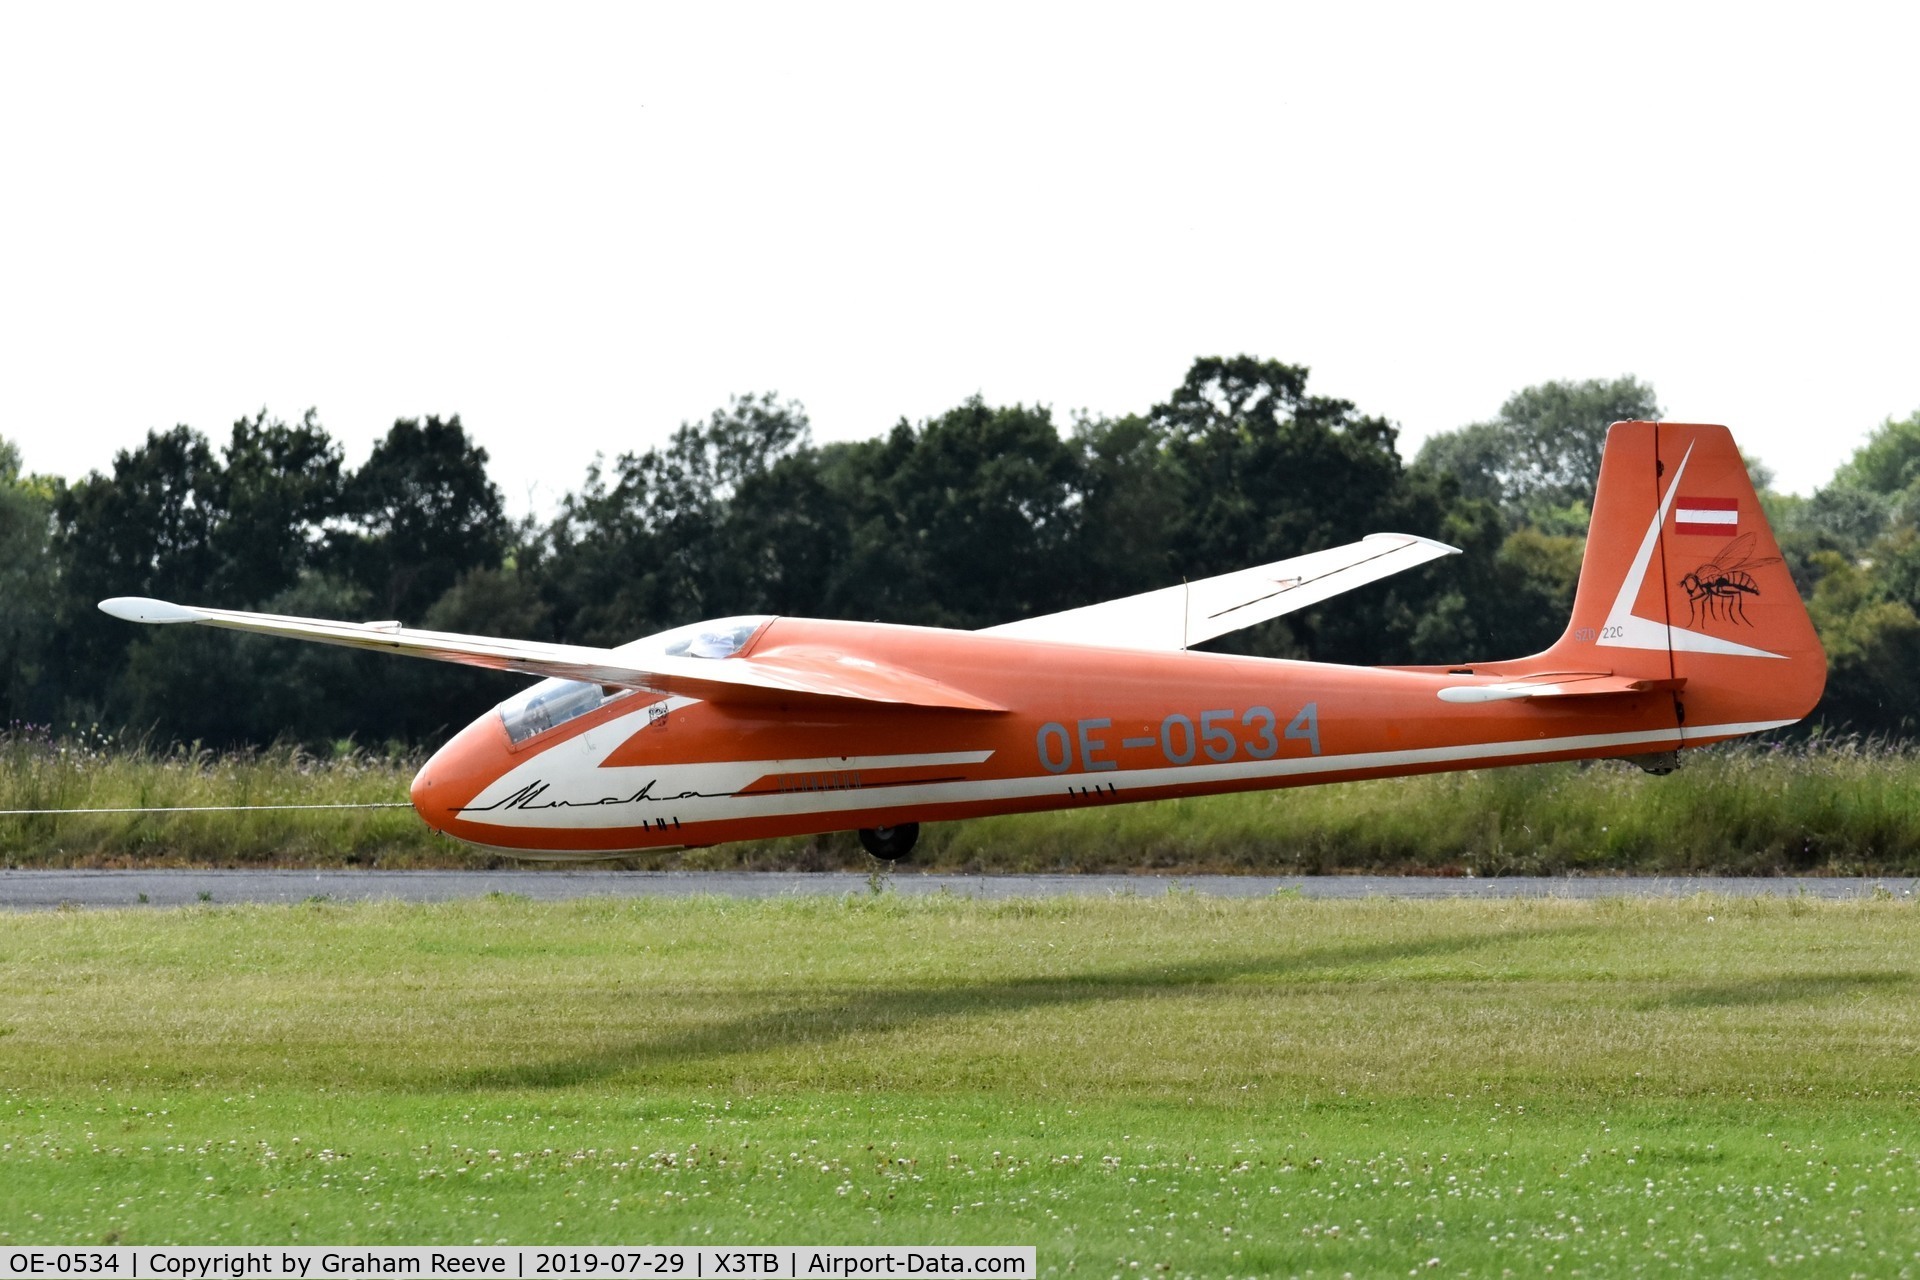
[[0, 871, 1920, 912]]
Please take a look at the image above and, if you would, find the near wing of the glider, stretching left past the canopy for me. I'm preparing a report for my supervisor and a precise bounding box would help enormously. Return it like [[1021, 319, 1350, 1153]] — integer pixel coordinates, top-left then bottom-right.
[[100, 597, 1004, 712]]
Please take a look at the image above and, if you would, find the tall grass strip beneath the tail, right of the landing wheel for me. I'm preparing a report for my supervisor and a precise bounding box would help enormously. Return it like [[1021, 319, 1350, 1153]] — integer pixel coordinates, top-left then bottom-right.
[[910, 739, 1920, 875]]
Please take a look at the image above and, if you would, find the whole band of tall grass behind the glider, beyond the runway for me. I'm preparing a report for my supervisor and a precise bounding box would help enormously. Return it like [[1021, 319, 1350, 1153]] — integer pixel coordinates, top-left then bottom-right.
[[0, 729, 1920, 875]]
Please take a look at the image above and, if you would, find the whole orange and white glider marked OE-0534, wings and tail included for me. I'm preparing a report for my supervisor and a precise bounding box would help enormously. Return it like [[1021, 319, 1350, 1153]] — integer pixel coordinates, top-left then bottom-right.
[[100, 422, 1826, 858]]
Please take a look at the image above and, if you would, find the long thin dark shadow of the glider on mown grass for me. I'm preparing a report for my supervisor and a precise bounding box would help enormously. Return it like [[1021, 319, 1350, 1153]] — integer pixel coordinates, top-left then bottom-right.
[[449, 925, 1601, 1088]]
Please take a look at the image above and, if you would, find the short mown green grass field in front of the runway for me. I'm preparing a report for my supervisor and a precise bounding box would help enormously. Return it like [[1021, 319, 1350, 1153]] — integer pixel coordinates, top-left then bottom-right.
[[0, 892, 1920, 1276]]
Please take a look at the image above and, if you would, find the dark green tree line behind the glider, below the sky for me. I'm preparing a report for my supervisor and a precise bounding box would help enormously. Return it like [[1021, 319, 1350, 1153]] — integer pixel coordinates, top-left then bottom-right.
[[0, 357, 1920, 747]]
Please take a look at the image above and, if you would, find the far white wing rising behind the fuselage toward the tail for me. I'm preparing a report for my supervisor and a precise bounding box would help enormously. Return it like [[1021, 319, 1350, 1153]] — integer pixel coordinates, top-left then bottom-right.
[[987, 533, 1459, 651]]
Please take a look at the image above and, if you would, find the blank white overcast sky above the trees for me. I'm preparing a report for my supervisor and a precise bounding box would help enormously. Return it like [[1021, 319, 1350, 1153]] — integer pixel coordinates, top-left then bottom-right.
[[0, 2, 1920, 510]]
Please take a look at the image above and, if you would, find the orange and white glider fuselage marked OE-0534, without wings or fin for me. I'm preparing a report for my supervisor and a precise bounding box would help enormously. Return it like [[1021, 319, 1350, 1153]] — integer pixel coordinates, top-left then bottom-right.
[[413, 618, 1728, 854]]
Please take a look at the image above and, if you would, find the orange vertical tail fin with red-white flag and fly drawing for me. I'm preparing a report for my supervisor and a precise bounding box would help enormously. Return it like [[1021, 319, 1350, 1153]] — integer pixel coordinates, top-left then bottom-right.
[[1538, 422, 1826, 743]]
